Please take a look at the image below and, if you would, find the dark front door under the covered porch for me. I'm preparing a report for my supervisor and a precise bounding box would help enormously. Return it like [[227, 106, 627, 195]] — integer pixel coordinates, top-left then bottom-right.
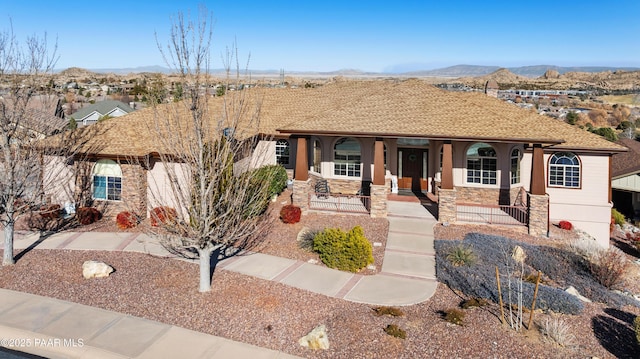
[[398, 148, 428, 192]]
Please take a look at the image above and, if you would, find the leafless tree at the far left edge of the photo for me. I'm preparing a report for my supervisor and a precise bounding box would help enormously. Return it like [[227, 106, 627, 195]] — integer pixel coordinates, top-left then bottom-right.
[[0, 23, 65, 265]]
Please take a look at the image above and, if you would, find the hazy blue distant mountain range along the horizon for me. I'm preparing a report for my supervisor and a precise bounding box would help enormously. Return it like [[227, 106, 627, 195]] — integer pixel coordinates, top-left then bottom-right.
[[58, 65, 640, 78]]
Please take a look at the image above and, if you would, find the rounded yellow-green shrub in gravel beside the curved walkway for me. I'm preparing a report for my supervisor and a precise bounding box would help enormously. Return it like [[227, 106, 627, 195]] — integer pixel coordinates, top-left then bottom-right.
[[313, 226, 373, 272]]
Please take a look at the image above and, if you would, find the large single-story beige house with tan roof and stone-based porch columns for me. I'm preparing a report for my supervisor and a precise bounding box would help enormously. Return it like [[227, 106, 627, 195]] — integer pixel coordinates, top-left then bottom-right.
[[43, 79, 626, 246]]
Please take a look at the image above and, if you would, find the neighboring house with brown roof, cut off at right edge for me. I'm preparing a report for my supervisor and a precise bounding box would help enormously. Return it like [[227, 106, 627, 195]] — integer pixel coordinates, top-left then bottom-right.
[[611, 138, 640, 220]]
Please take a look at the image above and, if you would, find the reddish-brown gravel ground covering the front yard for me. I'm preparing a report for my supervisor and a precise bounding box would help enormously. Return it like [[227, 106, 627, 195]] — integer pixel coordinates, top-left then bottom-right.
[[0, 196, 640, 358]]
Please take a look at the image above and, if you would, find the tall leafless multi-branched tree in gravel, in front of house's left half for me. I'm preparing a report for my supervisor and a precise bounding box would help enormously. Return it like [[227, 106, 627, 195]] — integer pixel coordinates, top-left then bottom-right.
[[142, 8, 272, 292]]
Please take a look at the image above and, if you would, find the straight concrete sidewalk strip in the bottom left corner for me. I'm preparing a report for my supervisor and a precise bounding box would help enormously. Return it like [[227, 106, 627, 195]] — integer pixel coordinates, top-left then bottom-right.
[[0, 289, 297, 359]]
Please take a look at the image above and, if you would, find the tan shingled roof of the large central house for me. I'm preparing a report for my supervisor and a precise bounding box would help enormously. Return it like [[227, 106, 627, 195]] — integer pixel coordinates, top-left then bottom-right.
[[53, 80, 625, 156]]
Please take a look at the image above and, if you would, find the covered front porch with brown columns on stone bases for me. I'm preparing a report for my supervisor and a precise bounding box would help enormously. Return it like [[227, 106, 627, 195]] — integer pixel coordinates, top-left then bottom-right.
[[290, 134, 549, 235]]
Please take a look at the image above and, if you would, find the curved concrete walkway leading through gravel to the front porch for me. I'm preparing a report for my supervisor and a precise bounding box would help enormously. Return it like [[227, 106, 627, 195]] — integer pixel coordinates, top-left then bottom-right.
[[2, 201, 437, 306]]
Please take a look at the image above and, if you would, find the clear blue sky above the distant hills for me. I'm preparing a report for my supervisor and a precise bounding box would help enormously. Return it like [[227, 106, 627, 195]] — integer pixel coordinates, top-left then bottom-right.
[[0, 0, 640, 72]]
